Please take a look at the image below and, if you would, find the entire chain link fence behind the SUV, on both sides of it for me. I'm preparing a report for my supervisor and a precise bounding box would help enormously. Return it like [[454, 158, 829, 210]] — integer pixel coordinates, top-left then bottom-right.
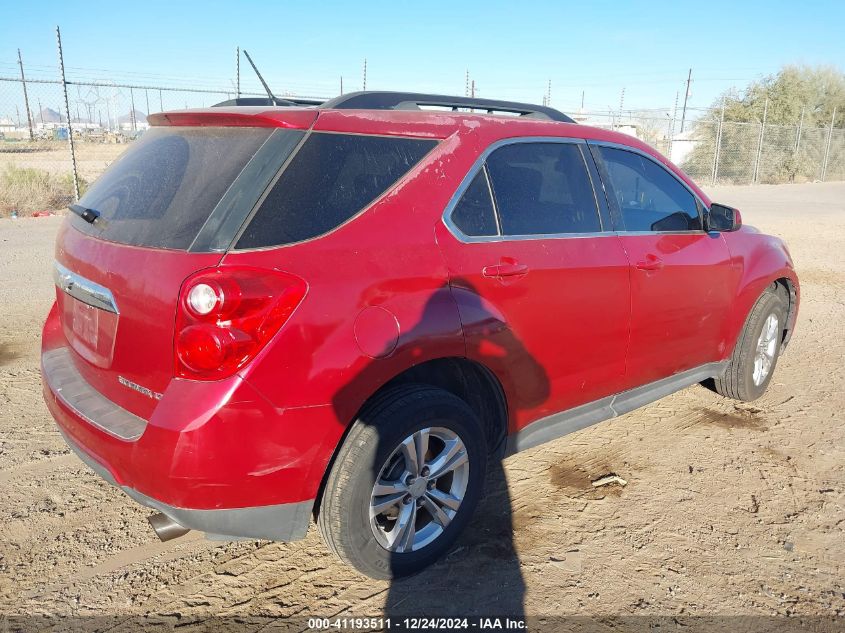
[[0, 64, 845, 216]]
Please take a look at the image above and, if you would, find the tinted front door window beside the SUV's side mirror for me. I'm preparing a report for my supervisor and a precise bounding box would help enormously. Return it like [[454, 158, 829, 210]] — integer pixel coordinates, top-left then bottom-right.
[[598, 146, 702, 231]]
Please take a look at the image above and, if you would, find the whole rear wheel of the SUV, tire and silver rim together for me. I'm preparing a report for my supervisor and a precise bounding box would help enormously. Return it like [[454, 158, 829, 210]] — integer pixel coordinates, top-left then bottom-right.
[[317, 385, 487, 578]]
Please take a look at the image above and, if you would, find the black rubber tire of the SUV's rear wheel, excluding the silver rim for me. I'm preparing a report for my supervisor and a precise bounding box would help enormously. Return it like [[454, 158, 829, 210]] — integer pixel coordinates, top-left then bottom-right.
[[317, 385, 487, 579]]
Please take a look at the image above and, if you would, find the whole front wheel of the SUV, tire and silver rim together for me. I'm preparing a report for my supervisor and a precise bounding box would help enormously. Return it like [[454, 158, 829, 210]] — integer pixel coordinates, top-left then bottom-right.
[[714, 288, 787, 402]]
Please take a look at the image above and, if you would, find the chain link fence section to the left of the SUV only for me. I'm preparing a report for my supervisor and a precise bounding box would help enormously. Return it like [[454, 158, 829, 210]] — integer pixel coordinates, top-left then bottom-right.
[[0, 76, 258, 215]]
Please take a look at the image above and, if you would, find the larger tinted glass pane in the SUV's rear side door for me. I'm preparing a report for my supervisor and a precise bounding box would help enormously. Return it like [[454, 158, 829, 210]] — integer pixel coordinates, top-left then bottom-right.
[[487, 143, 601, 235]]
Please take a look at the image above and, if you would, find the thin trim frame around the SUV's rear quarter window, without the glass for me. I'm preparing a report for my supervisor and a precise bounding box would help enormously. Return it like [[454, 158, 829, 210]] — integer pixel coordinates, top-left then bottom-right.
[[231, 129, 443, 254]]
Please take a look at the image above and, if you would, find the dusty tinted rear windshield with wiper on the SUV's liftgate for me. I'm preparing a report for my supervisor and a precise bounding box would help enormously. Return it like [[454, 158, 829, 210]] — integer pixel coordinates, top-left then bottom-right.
[[71, 127, 273, 250]]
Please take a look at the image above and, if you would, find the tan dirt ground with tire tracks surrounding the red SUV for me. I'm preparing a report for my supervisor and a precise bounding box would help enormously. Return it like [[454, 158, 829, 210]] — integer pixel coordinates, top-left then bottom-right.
[[0, 183, 845, 630]]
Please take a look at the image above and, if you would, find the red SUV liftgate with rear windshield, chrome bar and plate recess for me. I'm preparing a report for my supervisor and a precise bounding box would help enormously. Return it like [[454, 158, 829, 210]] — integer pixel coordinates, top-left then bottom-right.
[[54, 127, 304, 417]]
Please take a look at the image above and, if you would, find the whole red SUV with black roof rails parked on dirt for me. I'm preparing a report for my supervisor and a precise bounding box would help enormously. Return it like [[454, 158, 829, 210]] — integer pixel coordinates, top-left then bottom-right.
[[41, 92, 799, 578]]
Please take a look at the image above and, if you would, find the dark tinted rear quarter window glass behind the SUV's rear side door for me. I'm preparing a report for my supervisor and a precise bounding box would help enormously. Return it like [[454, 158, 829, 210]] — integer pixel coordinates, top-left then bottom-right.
[[236, 132, 437, 249]]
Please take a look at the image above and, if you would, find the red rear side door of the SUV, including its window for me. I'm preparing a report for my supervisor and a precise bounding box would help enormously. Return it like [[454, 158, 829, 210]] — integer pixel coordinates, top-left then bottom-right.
[[438, 139, 630, 430]]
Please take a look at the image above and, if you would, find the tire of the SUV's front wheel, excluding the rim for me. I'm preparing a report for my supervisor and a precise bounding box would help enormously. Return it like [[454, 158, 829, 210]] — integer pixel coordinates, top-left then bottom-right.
[[714, 286, 787, 402]]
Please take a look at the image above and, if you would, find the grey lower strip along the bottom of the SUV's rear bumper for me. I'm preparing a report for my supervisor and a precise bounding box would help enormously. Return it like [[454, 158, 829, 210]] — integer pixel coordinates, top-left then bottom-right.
[[62, 424, 314, 541]]
